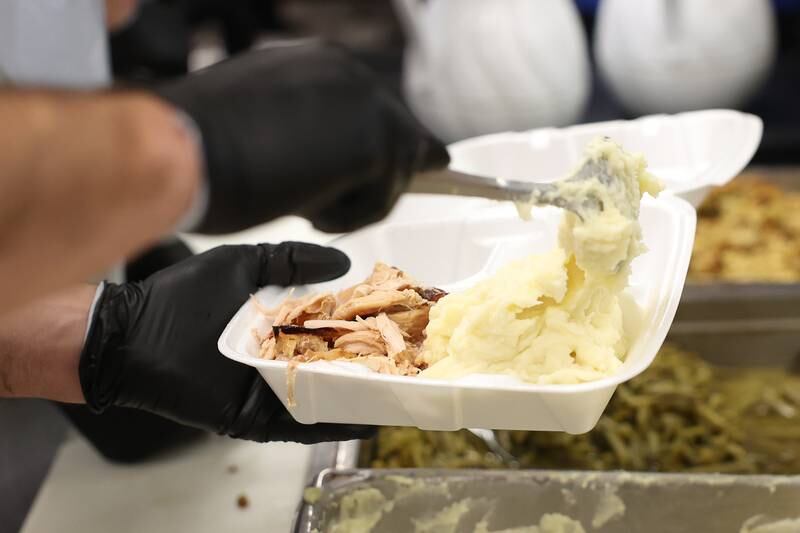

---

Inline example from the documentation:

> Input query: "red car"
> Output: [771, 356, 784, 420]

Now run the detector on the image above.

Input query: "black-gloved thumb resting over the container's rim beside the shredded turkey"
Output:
[257, 242, 350, 287]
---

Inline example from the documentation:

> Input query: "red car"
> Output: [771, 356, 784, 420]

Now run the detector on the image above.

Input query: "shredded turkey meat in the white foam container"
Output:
[254, 263, 445, 380]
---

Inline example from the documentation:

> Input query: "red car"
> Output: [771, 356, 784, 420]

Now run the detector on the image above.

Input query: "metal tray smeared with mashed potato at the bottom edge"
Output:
[294, 469, 800, 533]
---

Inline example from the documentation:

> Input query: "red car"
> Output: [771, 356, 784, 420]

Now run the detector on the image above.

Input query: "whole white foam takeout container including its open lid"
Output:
[219, 110, 763, 433]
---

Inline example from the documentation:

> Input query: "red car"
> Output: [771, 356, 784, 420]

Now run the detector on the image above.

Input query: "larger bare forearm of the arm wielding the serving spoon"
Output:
[0, 90, 201, 314]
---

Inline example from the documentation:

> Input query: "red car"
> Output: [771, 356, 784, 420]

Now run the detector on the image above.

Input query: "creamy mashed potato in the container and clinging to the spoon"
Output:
[421, 139, 660, 383]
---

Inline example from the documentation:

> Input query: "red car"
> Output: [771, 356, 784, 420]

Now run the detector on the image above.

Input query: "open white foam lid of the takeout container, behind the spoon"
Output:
[449, 109, 763, 207]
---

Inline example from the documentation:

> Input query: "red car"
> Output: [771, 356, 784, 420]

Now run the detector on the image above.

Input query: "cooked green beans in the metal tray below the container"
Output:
[364, 346, 800, 474]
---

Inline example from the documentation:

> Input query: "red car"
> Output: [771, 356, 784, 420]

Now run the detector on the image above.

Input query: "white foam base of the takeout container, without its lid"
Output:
[219, 191, 695, 433]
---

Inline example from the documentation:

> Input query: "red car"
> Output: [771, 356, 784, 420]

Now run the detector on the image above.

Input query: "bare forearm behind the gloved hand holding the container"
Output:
[0, 285, 96, 403]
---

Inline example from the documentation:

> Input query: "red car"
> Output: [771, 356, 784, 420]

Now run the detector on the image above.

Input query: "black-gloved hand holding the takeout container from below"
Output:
[79, 243, 371, 443]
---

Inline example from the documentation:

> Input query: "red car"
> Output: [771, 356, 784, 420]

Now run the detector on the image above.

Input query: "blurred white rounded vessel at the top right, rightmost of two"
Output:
[595, 0, 776, 114]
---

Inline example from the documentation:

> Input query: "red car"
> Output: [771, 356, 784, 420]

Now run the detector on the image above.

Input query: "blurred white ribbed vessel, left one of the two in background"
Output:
[395, 0, 591, 142]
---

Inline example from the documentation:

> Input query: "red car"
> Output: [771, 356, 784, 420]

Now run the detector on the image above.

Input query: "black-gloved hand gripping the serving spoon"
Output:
[156, 41, 449, 233]
